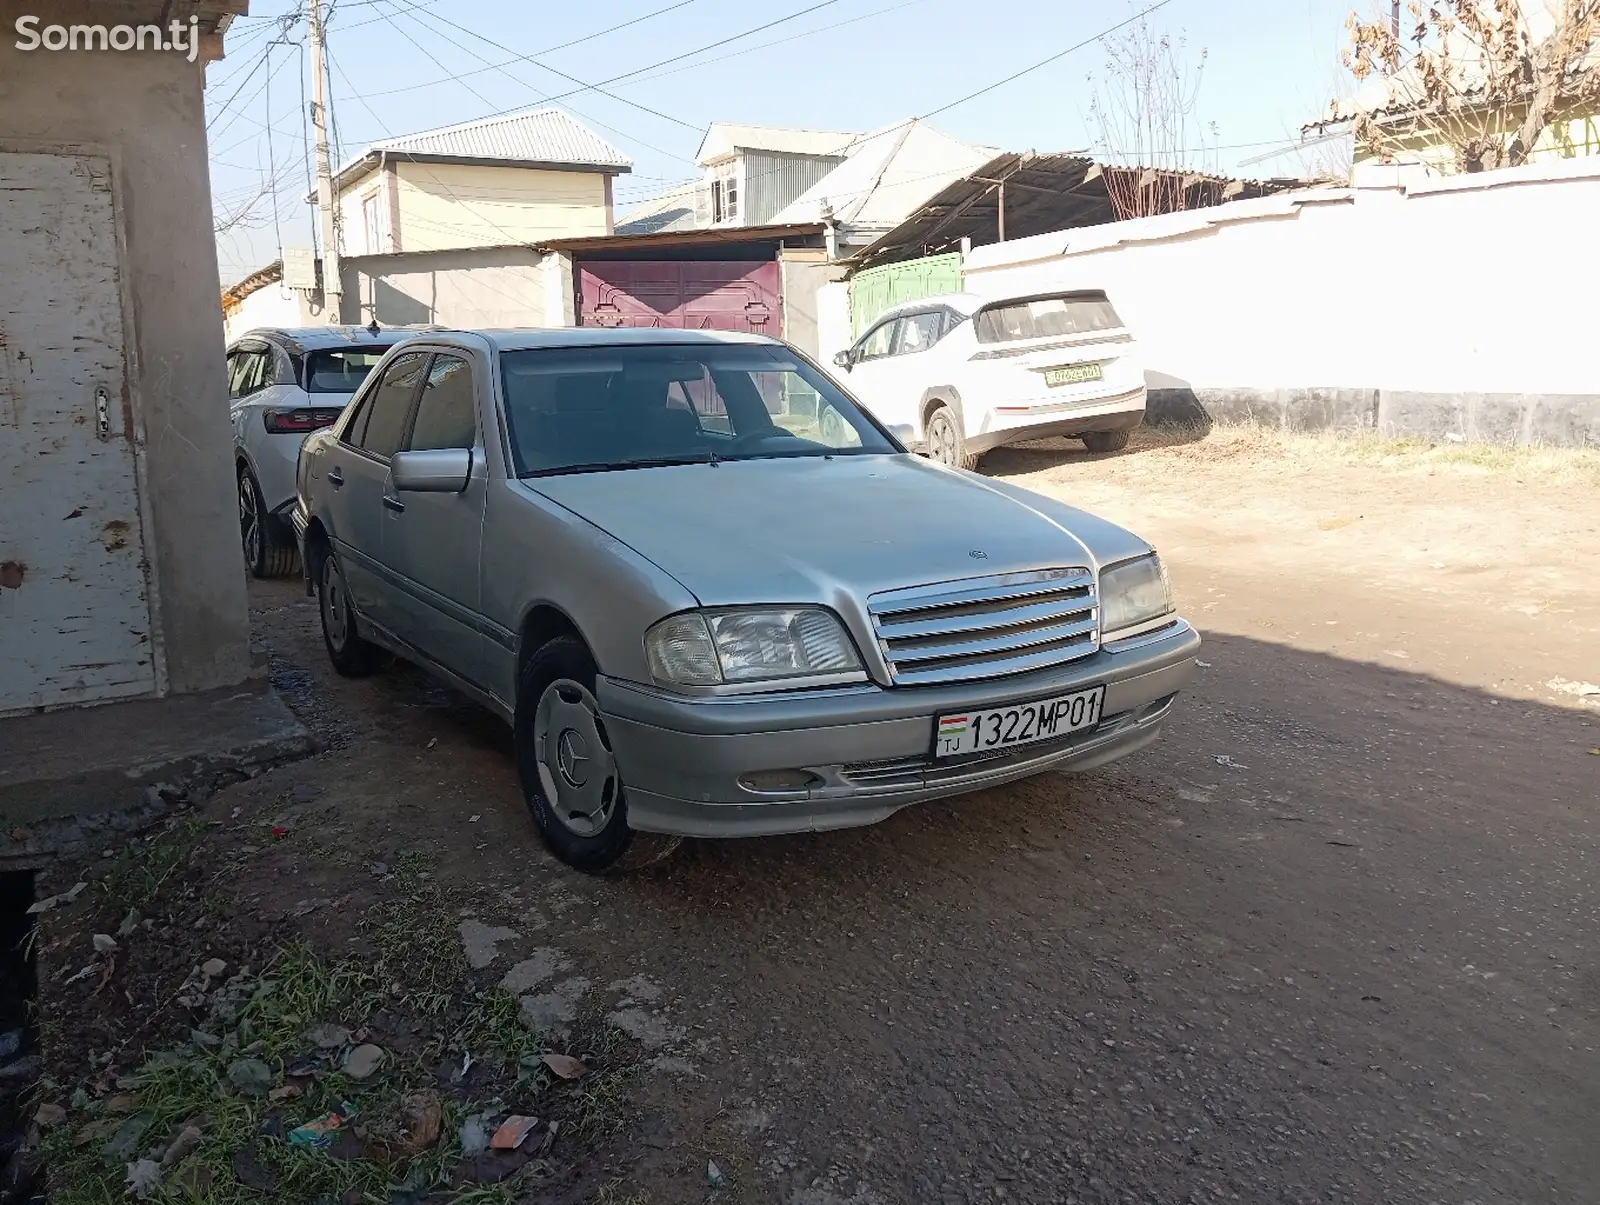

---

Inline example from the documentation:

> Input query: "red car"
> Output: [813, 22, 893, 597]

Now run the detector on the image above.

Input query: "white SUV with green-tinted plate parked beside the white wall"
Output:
[834, 291, 1144, 469]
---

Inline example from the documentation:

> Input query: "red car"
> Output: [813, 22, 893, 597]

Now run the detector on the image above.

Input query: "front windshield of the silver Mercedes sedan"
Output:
[501, 344, 901, 477]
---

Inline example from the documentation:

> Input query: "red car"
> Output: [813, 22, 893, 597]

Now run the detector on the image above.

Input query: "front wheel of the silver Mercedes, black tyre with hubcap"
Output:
[514, 635, 680, 872]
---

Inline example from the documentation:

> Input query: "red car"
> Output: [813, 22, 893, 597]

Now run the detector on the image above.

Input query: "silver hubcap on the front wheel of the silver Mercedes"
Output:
[533, 679, 621, 837]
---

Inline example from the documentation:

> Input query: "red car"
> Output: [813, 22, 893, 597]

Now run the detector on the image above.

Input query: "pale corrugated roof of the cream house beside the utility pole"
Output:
[339, 109, 634, 190]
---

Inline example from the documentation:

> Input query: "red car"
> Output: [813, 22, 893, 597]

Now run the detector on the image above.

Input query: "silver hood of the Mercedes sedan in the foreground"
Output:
[526, 454, 1149, 610]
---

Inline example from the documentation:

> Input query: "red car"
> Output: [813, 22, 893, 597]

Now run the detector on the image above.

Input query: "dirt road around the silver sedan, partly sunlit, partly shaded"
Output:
[28, 430, 1600, 1205]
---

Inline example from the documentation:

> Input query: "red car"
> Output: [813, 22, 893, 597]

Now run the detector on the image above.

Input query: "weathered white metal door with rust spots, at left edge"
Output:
[0, 152, 159, 715]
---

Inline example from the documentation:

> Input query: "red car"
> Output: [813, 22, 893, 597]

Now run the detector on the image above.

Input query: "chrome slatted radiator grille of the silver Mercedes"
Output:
[867, 568, 1099, 687]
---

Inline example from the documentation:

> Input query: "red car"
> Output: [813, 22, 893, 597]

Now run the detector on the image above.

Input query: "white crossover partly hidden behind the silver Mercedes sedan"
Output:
[227, 326, 418, 578]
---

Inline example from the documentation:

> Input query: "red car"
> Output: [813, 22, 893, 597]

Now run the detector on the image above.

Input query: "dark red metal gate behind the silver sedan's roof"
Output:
[578, 259, 782, 339]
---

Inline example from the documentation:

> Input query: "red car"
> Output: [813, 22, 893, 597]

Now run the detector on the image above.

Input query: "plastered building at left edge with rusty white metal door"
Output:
[0, 0, 251, 713]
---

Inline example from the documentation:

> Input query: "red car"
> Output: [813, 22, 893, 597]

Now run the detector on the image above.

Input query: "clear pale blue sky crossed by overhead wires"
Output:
[208, 0, 1373, 282]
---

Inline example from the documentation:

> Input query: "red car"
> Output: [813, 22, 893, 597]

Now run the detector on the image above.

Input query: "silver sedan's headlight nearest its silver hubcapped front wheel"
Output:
[645, 607, 866, 687]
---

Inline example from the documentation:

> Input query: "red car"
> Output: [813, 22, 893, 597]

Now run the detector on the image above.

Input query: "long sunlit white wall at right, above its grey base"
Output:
[965, 160, 1600, 442]
